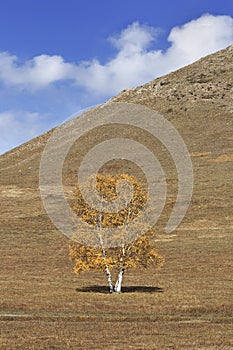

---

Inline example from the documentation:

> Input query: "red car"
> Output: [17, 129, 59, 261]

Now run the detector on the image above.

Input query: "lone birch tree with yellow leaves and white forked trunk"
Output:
[70, 174, 163, 293]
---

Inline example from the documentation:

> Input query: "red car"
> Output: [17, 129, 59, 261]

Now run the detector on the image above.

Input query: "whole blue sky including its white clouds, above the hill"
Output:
[0, 0, 233, 153]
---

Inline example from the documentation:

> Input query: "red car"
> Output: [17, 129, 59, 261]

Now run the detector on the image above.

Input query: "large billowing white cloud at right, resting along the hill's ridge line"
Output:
[77, 14, 233, 94]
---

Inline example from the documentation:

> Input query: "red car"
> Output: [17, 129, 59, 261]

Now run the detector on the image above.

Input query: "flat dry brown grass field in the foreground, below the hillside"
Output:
[0, 230, 233, 349]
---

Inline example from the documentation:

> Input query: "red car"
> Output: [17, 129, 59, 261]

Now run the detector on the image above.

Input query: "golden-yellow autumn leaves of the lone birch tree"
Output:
[70, 174, 163, 273]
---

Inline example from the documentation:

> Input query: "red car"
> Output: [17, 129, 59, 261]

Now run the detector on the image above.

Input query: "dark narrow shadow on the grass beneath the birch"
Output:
[76, 286, 163, 294]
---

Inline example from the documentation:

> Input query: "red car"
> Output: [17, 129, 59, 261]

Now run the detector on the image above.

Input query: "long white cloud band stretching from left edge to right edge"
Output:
[0, 14, 233, 96]
